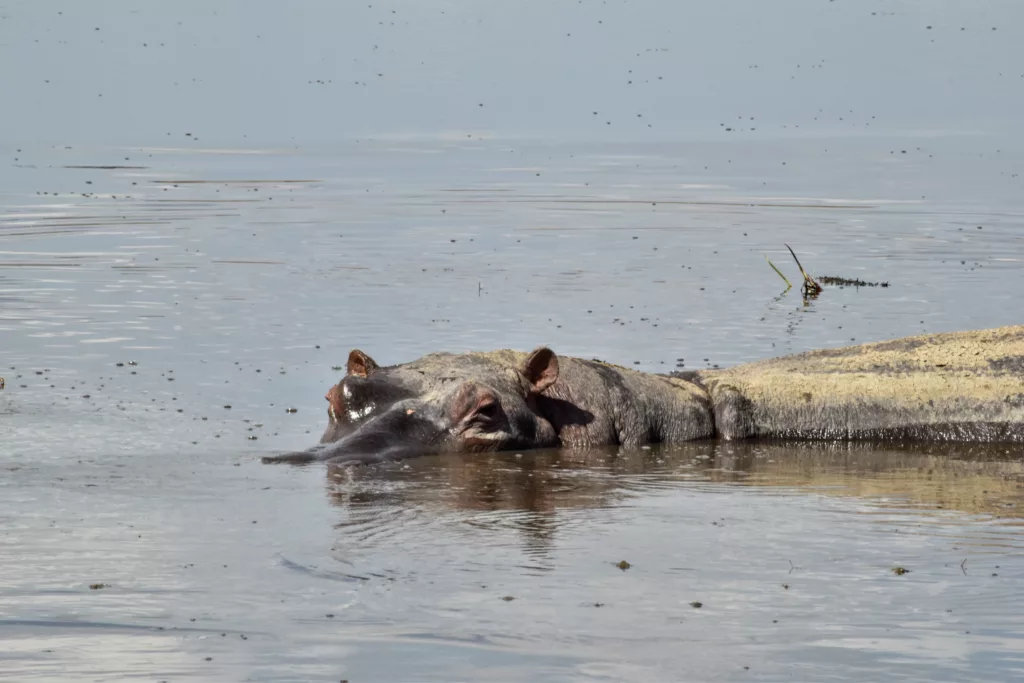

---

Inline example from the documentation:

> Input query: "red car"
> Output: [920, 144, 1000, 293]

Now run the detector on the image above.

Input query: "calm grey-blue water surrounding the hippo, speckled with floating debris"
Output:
[0, 0, 1024, 683]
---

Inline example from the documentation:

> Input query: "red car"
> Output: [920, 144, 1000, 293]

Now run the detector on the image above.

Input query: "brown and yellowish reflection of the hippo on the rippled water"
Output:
[328, 442, 1024, 565]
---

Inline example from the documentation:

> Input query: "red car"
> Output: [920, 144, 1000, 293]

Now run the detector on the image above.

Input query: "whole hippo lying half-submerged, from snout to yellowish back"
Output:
[264, 326, 1024, 463]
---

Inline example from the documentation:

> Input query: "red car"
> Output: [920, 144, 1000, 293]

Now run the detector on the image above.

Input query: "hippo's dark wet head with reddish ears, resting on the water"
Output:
[265, 347, 558, 463]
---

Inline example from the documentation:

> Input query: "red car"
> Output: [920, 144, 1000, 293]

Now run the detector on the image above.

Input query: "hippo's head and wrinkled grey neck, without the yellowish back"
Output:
[264, 347, 713, 463]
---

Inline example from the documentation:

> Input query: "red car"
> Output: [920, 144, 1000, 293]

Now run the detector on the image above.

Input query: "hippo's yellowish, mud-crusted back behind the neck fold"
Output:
[697, 326, 1024, 442]
